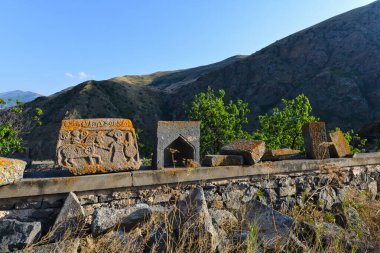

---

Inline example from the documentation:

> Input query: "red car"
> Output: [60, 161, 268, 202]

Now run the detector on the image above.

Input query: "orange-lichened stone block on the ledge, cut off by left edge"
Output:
[0, 157, 26, 186]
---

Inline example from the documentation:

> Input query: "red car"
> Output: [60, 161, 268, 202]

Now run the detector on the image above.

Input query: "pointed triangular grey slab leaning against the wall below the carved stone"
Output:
[50, 192, 86, 241]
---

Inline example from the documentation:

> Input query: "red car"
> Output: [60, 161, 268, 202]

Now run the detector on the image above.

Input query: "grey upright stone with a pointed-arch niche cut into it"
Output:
[153, 121, 201, 169]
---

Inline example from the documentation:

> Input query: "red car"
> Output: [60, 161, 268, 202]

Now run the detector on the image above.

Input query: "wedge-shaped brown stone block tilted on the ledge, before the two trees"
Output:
[220, 140, 265, 165]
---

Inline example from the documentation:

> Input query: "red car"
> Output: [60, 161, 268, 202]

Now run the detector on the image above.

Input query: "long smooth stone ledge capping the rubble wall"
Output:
[0, 155, 380, 199]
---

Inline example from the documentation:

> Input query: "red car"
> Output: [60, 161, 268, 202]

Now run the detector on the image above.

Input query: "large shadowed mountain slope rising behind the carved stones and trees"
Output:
[0, 1, 380, 159]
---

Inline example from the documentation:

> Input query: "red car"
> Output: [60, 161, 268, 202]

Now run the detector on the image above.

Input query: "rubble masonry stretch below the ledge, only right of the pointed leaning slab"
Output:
[78, 165, 380, 215]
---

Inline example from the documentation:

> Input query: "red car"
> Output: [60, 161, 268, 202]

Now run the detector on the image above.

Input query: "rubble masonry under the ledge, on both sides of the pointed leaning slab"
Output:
[0, 160, 380, 230]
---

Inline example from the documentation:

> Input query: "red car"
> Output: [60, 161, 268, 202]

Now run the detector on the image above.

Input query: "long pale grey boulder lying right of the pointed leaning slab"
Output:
[91, 204, 152, 236]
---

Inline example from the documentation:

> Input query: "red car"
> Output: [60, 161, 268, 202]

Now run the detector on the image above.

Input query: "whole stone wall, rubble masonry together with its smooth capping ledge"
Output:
[0, 158, 380, 231]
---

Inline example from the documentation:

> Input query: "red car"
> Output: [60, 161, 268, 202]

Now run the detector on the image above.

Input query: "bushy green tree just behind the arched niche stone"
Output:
[186, 87, 251, 156]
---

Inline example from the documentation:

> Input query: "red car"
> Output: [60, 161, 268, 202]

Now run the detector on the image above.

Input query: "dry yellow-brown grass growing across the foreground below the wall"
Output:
[26, 187, 380, 253]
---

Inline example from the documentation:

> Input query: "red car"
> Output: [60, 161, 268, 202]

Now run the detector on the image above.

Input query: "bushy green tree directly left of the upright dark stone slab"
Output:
[253, 94, 319, 150]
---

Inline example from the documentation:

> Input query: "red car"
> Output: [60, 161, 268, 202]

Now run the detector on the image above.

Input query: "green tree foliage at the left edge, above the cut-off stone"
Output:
[0, 98, 43, 156]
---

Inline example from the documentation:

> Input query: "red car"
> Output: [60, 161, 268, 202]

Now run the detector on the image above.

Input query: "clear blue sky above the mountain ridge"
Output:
[0, 0, 373, 95]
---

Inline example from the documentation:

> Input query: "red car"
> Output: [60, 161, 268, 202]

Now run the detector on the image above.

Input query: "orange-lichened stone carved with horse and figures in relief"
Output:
[56, 119, 141, 175]
